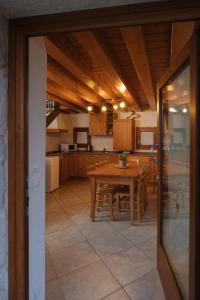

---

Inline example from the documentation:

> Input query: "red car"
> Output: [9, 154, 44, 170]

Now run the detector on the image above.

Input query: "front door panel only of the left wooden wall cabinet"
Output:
[89, 113, 108, 135]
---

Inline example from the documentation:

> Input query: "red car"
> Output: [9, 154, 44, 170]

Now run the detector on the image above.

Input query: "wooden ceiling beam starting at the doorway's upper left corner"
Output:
[44, 34, 115, 99]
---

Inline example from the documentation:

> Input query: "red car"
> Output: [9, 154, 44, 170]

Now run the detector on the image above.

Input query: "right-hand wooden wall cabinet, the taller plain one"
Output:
[113, 119, 135, 151]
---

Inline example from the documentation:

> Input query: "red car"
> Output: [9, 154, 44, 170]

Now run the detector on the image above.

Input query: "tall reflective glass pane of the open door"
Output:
[161, 66, 190, 299]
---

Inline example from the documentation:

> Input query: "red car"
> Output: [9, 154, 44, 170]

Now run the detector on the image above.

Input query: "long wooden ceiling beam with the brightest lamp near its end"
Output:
[73, 31, 141, 110]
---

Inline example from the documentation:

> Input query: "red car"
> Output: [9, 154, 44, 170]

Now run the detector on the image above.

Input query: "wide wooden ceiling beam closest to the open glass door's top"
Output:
[120, 26, 156, 110]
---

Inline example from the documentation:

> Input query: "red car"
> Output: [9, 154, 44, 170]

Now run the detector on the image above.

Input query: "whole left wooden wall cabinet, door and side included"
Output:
[89, 112, 117, 135]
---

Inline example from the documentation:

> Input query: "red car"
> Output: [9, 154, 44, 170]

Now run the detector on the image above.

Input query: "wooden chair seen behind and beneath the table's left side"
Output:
[88, 160, 116, 221]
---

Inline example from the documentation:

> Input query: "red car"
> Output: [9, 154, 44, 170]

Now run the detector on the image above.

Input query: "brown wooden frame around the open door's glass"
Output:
[157, 30, 200, 300]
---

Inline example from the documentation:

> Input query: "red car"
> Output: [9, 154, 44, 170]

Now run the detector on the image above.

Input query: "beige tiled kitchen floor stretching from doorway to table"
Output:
[46, 179, 165, 300]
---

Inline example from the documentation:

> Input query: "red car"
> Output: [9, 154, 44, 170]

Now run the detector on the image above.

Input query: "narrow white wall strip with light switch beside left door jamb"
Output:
[28, 38, 47, 300]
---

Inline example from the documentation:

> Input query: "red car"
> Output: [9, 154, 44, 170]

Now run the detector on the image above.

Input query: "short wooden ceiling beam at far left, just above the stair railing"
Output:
[47, 79, 89, 109]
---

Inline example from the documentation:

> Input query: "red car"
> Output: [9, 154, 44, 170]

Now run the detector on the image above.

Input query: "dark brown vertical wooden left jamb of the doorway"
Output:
[8, 24, 29, 299]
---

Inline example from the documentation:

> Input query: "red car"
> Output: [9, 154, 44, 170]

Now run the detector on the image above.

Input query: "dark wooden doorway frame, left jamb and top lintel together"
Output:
[8, 0, 200, 300]
